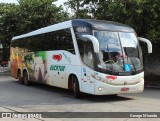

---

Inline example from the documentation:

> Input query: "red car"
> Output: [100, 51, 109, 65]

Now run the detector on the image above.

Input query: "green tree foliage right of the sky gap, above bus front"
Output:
[67, 0, 160, 42]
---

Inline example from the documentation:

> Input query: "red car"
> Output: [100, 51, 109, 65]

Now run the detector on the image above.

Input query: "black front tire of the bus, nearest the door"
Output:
[72, 77, 81, 99]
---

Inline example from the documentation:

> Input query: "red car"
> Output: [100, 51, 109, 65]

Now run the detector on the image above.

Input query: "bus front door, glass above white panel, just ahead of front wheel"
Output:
[80, 42, 95, 94]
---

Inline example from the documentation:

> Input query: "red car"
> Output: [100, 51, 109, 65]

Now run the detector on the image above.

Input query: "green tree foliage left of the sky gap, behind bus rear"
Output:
[0, 0, 69, 59]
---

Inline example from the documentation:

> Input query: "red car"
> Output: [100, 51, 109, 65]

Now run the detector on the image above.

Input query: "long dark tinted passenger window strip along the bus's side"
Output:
[12, 29, 75, 54]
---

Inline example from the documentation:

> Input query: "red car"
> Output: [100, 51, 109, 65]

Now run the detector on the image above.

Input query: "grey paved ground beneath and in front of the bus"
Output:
[0, 72, 160, 121]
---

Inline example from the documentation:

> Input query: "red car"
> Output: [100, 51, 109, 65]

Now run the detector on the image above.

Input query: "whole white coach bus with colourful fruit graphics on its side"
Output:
[10, 19, 152, 98]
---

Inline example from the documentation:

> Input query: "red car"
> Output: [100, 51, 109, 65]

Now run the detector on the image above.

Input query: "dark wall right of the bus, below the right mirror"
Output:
[144, 43, 160, 87]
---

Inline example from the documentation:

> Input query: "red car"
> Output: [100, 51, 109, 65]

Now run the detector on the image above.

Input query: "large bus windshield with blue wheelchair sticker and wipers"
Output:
[94, 31, 143, 73]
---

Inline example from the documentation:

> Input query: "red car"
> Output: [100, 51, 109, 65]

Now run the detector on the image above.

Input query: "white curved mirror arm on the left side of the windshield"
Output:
[82, 35, 99, 53]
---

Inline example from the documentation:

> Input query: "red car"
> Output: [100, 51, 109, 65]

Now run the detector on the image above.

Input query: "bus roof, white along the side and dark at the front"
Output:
[12, 19, 134, 40]
